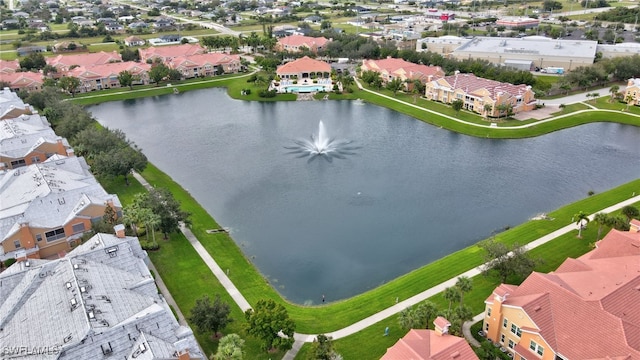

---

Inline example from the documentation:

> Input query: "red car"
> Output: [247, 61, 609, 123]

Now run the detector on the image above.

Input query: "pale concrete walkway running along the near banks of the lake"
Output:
[133, 172, 640, 360]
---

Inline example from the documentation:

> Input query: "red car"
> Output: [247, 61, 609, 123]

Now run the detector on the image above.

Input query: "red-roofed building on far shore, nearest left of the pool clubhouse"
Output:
[167, 53, 242, 79]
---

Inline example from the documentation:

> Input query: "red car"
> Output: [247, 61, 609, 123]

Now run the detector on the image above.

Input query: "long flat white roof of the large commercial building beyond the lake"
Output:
[455, 36, 598, 59]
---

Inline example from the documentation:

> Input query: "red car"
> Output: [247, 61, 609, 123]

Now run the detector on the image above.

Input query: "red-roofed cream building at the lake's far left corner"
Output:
[66, 61, 151, 92]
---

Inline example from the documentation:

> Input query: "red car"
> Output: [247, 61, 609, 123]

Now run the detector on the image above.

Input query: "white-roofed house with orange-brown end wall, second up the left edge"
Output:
[0, 114, 74, 170]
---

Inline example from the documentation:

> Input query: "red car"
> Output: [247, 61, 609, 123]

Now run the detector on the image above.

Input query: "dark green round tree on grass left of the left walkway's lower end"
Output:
[189, 294, 233, 336]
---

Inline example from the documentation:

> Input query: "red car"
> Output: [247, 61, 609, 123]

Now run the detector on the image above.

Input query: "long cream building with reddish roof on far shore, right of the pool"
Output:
[425, 72, 536, 117]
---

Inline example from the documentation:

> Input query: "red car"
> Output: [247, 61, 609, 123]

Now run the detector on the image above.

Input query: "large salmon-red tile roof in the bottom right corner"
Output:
[487, 230, 640, 359]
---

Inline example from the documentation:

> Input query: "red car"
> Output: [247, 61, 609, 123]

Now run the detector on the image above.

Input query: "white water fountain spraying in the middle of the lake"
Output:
[285, 120, 359, 162]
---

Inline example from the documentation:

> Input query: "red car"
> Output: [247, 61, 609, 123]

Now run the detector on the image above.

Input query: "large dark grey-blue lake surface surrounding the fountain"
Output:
[89, 89, 640, 303]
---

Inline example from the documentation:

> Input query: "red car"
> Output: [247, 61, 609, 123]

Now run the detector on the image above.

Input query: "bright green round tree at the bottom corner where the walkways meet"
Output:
[244, 299, 295, 350]
